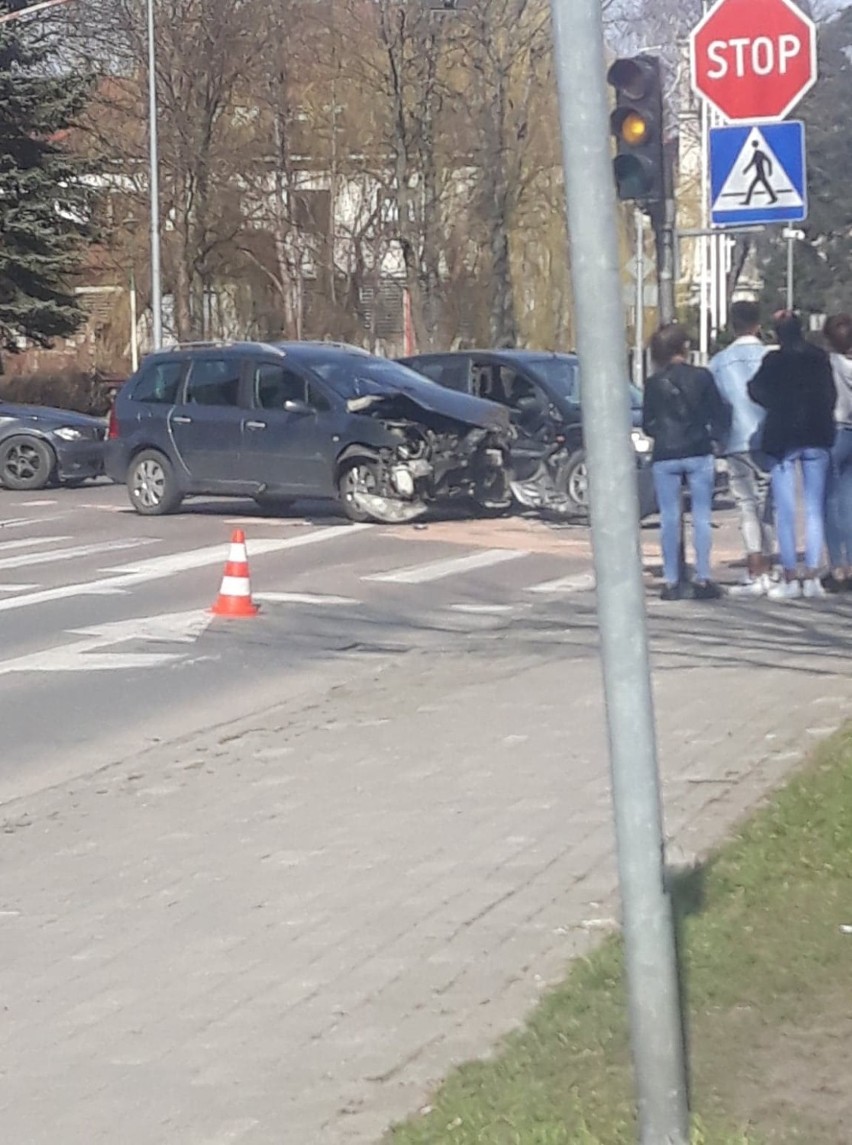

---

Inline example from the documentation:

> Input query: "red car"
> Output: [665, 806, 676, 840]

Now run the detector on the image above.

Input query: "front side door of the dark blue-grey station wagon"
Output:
[242, 361, 340, 497]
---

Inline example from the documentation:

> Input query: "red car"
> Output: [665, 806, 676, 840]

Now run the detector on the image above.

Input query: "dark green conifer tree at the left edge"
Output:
[0, 0, 92, 350]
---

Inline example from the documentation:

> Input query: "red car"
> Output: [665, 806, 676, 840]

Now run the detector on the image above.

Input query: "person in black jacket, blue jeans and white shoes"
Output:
[749, 310, 837, 600]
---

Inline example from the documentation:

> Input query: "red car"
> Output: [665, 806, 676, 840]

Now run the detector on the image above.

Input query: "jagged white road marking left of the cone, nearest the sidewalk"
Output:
[0, 609, 213, 676]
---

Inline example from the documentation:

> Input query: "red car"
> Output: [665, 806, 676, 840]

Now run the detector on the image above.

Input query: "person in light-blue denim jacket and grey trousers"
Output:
[710, 301, 775, 597]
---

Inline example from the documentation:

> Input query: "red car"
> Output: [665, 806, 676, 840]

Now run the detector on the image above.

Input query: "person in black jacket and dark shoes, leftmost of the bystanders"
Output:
[642, 324, 731, 600]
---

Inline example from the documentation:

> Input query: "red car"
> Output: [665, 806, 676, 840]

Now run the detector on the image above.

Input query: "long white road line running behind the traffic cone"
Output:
[0, 524, 372, 613]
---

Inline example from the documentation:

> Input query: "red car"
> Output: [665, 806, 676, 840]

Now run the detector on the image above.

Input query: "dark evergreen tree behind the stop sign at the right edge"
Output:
[760, 8, 852, 314]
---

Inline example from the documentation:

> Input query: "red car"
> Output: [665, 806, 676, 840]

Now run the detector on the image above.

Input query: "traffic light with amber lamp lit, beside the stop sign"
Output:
[607, 55, 666, 203]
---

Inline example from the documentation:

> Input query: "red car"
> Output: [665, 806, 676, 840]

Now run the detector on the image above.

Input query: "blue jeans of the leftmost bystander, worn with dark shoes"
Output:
[654, 453, 716, 584]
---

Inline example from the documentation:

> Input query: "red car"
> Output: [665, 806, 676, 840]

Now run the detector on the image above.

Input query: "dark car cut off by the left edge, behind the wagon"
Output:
[0, 401, 107, 489]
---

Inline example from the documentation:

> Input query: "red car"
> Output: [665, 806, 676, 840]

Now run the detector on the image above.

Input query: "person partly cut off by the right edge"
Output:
[822, 314, 852, 592]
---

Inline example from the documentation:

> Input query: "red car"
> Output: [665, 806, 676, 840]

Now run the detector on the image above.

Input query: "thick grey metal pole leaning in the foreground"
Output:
[551, 0, 689, 1145]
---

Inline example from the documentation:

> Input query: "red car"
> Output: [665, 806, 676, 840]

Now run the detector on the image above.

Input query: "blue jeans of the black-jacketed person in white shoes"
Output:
[772, 449, 830, 573]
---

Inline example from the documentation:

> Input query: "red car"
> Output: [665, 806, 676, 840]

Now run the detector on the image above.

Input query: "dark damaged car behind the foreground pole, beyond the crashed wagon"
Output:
[399, 350, 656, 516]
